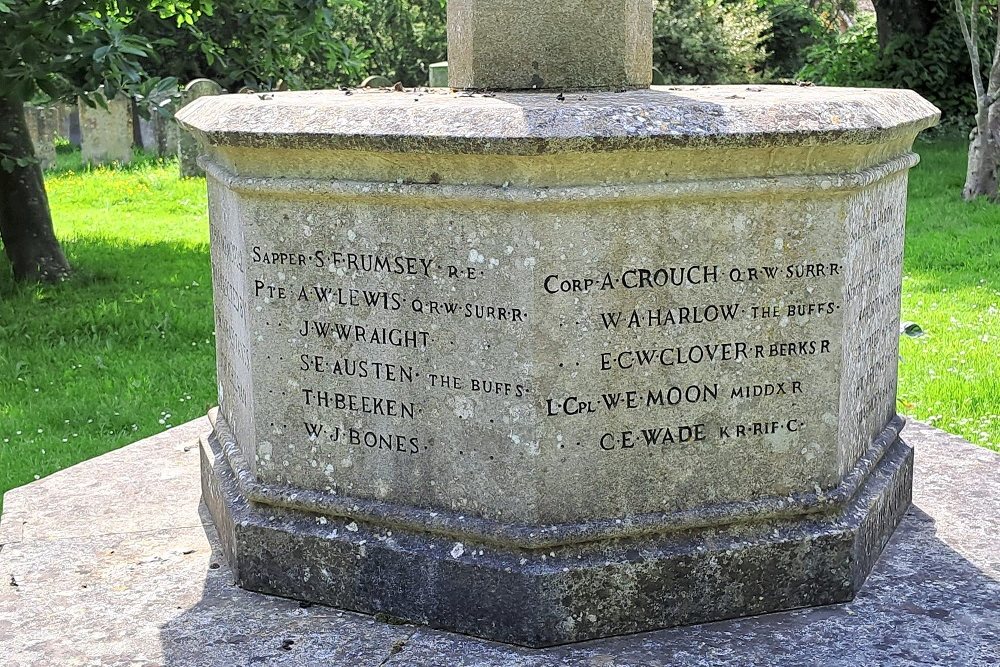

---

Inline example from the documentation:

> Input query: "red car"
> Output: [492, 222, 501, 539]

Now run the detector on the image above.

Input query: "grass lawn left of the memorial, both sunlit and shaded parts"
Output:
[0, 153, 215, 506]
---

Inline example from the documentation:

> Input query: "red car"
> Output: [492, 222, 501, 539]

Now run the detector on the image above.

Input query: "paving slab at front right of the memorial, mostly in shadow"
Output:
[388, 423, 1000, 667]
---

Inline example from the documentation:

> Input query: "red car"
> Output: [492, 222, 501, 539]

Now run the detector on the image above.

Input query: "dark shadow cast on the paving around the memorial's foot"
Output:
[160, 503, 1000, 667]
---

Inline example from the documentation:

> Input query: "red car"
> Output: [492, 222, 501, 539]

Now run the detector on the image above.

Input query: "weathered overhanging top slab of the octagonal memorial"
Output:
[177, 86, 940, 155]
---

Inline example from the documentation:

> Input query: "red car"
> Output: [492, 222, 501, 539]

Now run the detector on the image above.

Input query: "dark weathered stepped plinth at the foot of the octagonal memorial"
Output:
[201, 412, 913, 647]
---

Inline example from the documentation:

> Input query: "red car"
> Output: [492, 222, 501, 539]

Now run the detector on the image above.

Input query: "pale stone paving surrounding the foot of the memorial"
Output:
[0, 420, 1000, 667]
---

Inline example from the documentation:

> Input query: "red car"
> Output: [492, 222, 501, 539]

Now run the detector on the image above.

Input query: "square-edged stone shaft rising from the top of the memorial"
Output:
[448, 0, 653, 90]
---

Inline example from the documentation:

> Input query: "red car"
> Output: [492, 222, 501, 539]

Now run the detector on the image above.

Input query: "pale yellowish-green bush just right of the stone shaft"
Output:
[653, 0, 769, 84]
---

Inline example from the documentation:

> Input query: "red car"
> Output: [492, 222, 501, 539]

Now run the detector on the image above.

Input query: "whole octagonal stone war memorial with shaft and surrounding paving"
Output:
[0, 0, 1000, 667]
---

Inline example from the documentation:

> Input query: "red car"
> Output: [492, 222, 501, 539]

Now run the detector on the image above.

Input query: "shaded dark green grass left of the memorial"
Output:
[0, 239, 216, 504]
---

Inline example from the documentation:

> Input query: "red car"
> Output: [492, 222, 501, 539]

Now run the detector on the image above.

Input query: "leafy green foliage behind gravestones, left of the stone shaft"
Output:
[131, 0, 447, 90]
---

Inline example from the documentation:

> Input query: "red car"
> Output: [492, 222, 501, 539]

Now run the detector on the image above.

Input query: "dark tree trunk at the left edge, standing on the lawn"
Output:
[0, 97, 69, 282]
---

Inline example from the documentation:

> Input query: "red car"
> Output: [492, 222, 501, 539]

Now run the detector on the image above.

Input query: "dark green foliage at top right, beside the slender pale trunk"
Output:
[799, 5, 995, 124]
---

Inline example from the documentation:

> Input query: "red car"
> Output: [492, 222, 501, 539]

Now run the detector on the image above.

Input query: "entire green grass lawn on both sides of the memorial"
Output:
[0, 142, 1000, 506]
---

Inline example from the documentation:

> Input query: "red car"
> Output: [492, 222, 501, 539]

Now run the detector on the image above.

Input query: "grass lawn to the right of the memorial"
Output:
[899, 141, 1000, 451]
